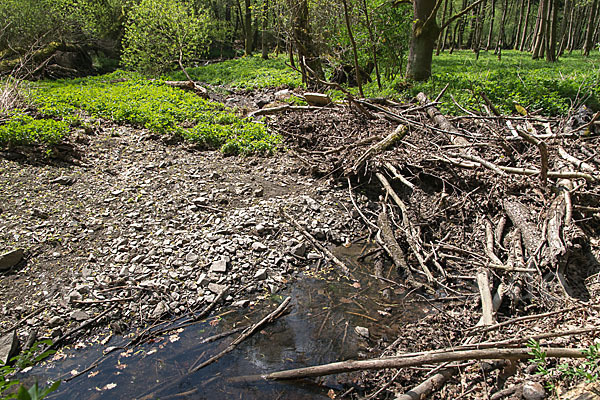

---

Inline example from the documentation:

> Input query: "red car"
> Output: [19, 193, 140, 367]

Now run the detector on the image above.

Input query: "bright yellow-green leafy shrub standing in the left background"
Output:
[122, 0, 211, 74]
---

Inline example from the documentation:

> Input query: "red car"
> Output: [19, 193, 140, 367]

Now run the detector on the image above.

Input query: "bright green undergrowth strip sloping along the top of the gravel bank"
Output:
[25, 71, 280, 154]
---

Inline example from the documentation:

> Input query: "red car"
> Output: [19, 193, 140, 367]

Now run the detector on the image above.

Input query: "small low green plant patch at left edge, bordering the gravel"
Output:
[0, 111, 69, 146]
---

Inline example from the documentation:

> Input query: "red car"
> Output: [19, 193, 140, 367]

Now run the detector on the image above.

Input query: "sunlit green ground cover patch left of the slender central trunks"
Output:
[169, 56, 302, 89]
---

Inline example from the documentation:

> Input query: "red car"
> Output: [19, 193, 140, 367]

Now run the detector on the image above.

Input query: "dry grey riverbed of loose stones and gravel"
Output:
[0, 126, 366, 354]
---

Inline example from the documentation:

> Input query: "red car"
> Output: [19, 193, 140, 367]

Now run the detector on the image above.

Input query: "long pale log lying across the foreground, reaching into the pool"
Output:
[258, 347, 585, 380]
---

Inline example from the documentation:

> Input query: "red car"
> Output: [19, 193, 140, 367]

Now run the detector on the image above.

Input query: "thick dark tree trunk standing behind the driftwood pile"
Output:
[406, 0, 440, 81]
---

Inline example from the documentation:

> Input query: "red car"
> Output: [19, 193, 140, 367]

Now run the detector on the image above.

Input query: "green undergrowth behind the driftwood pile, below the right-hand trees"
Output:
[356, 51, 600, 115]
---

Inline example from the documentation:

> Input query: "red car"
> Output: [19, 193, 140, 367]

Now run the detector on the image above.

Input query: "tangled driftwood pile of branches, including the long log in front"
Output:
[255, 93, 600, 399]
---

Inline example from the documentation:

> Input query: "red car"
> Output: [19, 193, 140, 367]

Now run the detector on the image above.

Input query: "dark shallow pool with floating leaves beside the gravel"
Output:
[30, 245, 427, 399]
